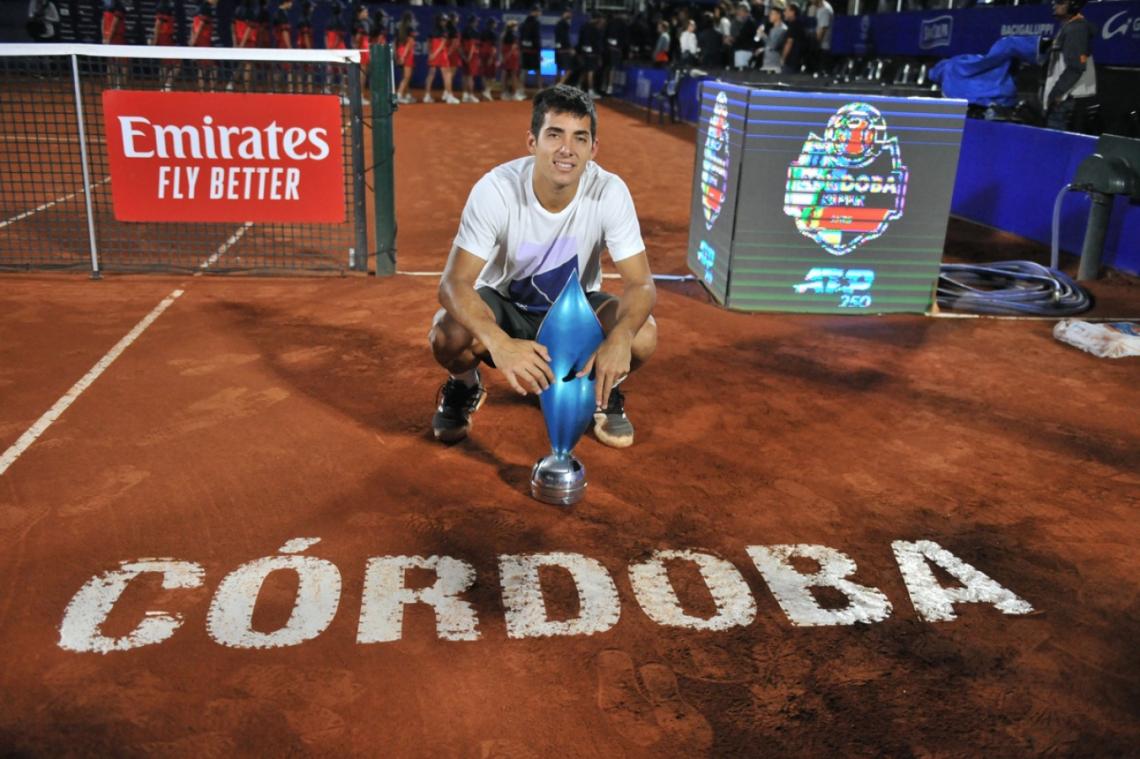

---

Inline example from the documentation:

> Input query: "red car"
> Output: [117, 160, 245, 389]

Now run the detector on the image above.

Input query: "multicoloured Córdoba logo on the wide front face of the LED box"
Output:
[784, 103, 907, 255]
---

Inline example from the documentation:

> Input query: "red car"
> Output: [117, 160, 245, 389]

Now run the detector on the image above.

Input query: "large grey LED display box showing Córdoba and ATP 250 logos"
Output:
[689, 81, 966, 313]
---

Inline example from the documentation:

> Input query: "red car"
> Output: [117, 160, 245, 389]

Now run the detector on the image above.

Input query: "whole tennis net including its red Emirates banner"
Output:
[0, 44, 368, 276]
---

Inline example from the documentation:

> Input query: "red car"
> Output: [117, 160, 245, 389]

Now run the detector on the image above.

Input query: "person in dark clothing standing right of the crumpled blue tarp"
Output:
[1042, 0, 1097, 130]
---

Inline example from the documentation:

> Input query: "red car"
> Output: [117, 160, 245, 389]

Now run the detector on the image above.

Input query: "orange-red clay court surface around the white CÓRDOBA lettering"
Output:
[0, 103, 1140, 757]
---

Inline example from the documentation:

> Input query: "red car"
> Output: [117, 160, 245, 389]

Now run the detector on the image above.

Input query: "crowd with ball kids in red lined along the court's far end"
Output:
[20, 0, 834, 104]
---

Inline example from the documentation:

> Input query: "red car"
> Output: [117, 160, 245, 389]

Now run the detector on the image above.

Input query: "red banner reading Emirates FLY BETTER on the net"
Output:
[103, 90, 344, 223]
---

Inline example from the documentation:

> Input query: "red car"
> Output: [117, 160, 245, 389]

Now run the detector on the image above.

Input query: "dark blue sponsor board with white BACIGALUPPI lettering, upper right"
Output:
[831, 0, 1140, 66]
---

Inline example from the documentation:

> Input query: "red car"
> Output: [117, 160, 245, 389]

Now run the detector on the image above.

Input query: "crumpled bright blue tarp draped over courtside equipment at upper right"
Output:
[930, 36, 1041, 107]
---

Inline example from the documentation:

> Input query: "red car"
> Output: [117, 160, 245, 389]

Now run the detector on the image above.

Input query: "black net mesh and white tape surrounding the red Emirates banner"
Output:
[0, 44, 368, 276]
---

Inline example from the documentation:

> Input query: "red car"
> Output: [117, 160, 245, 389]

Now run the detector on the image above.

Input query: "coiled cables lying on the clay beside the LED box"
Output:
[938, 261, 1092, 317]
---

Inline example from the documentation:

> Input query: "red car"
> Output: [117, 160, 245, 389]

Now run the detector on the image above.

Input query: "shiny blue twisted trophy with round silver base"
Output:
[530, 276, 605, 506]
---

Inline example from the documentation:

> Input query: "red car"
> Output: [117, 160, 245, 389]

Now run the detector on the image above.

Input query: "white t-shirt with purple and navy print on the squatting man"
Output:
[455, 156, 645, 313]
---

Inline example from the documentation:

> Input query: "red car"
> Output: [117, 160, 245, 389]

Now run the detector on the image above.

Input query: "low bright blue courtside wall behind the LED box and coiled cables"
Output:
[621, 67, 1140, 275]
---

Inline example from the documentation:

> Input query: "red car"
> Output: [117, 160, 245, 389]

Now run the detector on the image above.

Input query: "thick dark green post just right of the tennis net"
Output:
[371, 44, 396, 277]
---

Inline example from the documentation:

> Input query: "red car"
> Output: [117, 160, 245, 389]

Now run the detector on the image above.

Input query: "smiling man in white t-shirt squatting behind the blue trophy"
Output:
[430, 84, 657, 448]
